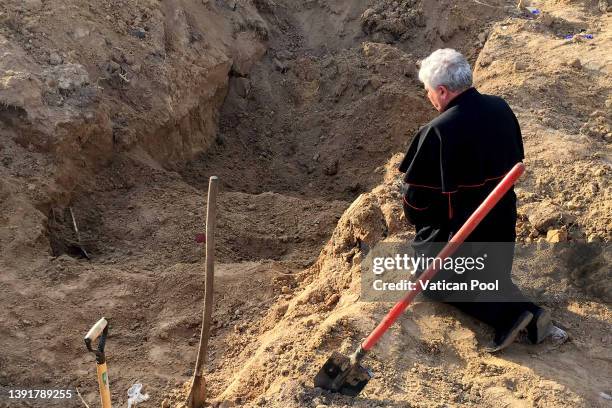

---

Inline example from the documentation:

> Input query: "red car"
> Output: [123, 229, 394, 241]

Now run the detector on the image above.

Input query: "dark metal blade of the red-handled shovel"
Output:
[314, 351, 372, 397]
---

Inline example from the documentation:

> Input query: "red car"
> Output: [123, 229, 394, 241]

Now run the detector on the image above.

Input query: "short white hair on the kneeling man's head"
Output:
[419, 48, 472, 92]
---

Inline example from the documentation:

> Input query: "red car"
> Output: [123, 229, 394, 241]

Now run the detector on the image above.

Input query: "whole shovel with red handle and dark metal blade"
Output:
[314, 163, 525, 396]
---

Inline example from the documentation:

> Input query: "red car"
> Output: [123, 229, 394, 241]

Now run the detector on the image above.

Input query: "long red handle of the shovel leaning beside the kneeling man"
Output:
[361, 163, 525, 351]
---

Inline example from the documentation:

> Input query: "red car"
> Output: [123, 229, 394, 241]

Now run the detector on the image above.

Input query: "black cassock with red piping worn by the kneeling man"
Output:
[399, 88, 539, 331]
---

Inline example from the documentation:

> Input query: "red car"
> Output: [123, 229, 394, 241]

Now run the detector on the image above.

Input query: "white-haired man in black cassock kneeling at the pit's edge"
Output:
[399, 49, 566, 351]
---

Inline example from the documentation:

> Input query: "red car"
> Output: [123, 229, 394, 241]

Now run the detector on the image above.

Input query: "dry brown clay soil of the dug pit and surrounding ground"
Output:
[0, 0, 612, 408]
